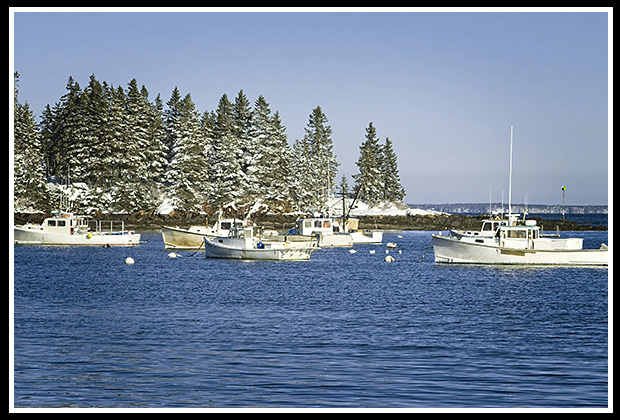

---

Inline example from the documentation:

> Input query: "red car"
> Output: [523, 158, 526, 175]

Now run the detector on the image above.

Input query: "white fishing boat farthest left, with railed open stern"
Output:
[13, 211, 140, 246]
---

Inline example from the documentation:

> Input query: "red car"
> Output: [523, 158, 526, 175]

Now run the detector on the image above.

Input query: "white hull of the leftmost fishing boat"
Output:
[13, 227, 140, 246]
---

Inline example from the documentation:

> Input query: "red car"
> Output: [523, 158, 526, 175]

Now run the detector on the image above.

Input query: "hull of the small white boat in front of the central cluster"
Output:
[204, 238, 319, 261]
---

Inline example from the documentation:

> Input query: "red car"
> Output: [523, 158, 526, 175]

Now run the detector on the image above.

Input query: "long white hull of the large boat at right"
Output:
[433, 235, 609, 266]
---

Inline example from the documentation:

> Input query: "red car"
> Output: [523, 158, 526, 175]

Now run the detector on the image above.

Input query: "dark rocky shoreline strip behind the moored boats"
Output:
[14, 211, 607, 232]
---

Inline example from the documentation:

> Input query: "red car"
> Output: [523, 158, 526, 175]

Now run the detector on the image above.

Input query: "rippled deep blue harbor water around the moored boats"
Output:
[14, 228, 608, 408]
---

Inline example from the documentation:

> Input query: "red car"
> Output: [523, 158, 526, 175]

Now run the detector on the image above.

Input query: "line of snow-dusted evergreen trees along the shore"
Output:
[13, 73, 405, 213]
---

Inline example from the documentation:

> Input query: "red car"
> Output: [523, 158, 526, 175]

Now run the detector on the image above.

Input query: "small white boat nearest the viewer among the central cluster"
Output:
[204, 226, 320, 260]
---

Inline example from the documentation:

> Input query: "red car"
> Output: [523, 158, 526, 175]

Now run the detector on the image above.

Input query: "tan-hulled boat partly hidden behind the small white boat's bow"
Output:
[161, 217, 247, 249]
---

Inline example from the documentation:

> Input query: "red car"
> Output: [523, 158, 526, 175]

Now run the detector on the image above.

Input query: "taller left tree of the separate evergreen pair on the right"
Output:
[354, 122, 384, 206]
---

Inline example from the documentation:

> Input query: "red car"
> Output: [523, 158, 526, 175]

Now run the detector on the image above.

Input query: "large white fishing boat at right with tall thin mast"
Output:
[432, 125, 609, 266]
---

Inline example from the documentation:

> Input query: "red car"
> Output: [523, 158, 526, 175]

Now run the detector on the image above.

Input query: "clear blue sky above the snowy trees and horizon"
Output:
[11, 9, 611, 204]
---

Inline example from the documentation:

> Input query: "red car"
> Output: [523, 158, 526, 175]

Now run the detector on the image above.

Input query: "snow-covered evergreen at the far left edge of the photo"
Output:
[13, 73, 50, 209]
